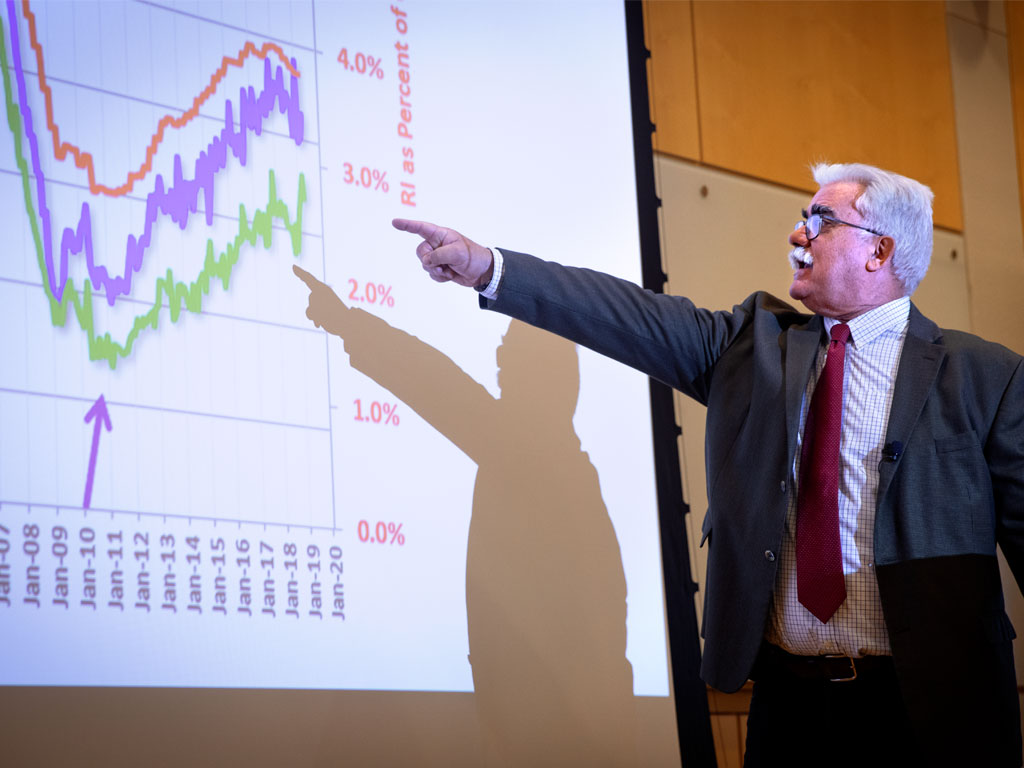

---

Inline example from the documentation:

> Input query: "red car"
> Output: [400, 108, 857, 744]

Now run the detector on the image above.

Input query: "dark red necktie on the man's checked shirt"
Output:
[797, 323, 850, 624]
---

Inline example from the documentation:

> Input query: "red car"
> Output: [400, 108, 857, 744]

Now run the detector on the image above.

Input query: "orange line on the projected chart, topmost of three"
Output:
[22, 0, 299, 198]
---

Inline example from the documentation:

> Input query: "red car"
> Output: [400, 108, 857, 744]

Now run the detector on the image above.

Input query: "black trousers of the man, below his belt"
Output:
[743, 646, 924, 768]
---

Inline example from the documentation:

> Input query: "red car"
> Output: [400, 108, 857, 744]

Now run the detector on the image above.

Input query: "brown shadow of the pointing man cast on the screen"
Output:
[296, 268, 635, 766]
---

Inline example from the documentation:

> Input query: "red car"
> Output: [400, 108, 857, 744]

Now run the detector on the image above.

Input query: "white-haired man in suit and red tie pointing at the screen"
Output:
[310, 165, 1024, 766]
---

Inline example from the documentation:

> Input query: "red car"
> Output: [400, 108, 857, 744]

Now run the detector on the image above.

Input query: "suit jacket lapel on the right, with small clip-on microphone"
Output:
[878, 303, 946, 509]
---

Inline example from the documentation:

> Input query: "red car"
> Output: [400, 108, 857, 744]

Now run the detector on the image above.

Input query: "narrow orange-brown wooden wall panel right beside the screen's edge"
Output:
[643, 0, 700, 160]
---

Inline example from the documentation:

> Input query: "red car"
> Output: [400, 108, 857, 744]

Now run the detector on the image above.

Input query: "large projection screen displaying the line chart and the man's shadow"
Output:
[0, 0, 696, 765]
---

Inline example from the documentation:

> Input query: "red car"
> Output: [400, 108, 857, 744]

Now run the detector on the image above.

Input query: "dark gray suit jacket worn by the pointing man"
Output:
[481, 249, 1024, 765]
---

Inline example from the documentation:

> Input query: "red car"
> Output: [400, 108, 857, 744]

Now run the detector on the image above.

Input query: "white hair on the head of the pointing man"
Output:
[811, 163, 935, 296]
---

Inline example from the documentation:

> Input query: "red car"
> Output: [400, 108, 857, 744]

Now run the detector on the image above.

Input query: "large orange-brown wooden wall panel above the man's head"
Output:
[688, 1, 963, 230]
